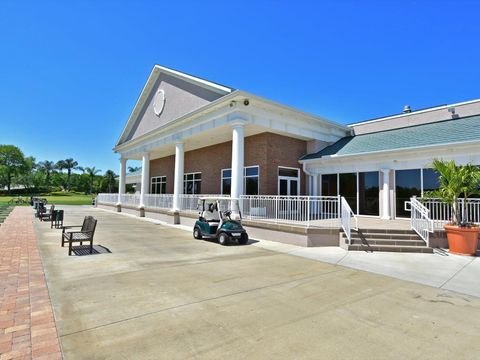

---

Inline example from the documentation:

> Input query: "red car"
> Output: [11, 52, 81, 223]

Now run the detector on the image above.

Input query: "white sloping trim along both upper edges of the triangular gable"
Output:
[116, 65, 235, 146]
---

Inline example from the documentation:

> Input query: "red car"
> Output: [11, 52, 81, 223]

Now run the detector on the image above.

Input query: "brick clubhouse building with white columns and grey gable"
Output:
[96, 65, 480, 248]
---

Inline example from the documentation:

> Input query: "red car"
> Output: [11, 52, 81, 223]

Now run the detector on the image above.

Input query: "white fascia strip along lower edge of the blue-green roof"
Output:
[299, 140, 480, 164]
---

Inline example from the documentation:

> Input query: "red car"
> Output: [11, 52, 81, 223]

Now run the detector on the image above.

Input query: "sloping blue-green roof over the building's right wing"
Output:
[300, 115, 480, 160]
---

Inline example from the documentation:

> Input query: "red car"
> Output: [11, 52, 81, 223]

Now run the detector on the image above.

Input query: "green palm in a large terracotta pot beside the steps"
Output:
[427, 159, 480, 255]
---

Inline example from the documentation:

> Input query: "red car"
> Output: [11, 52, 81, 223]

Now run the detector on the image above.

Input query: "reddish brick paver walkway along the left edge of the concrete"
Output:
[0, 207, 62, 360]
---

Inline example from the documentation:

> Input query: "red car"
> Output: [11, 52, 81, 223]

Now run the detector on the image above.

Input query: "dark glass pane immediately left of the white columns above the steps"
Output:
[358, 171, 380, 216]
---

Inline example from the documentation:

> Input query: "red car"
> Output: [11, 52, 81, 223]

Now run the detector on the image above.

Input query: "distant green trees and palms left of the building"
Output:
[0, 145, 124, 194]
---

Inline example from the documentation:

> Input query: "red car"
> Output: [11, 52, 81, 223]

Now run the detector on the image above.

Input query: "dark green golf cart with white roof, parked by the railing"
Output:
[193, 197, 248, 245]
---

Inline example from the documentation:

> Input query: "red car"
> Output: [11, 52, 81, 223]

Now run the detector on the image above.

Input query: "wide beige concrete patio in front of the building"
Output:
[35, 206, 480, 359]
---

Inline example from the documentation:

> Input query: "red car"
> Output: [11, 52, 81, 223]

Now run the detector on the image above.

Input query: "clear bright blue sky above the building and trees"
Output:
[0, 0, 480, 171]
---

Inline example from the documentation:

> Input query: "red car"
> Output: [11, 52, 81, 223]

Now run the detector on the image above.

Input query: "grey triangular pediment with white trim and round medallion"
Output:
[117, 65, 233, 146]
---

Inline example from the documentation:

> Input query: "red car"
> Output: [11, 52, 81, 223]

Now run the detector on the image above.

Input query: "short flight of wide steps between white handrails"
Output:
[341, 229, 433, 253]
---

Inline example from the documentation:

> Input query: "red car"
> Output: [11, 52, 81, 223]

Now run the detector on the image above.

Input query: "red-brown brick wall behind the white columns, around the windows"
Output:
[150, 133, 307, 195]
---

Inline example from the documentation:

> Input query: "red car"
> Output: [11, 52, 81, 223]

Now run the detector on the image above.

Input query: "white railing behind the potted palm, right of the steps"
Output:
[421, 198, 480, 230]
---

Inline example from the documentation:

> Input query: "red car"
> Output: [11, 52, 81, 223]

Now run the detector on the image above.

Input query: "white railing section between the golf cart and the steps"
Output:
[239, 195, 340, 227]
